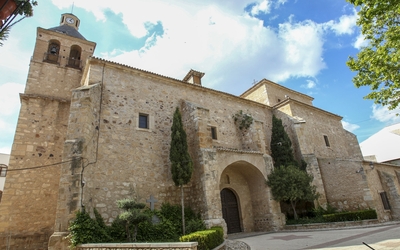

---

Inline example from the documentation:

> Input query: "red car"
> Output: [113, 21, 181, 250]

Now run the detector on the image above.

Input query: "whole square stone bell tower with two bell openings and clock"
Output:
[0, 13, 96, 249]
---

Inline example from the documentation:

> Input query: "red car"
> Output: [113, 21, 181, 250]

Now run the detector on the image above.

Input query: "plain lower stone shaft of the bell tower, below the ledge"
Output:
[0, 95, 69, 249]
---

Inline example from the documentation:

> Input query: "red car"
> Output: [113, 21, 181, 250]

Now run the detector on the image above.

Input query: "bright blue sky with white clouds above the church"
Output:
[0, 0, 400, 153]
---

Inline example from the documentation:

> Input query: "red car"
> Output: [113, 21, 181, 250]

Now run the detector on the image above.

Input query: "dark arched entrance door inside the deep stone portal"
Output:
[221, 188, 242, 234]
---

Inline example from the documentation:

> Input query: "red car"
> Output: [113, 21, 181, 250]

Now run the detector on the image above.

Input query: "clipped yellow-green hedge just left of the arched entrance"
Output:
[179, 227, 224, 250]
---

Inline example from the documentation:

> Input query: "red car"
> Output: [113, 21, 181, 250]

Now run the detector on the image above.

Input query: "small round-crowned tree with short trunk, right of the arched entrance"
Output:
[267, 165, 318, 219]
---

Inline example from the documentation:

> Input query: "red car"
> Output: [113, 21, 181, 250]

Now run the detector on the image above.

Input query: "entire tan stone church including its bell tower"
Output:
[0, 13, 400, 249]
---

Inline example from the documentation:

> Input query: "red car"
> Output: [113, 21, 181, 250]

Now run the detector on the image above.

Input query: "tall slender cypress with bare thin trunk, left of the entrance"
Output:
[169, 108, 193, 234]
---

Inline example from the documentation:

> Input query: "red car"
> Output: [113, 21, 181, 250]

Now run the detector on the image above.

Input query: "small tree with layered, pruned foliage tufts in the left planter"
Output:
[117, 199, 148, 242]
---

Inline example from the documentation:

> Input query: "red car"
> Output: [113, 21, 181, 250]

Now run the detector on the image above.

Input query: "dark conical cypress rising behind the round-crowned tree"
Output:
[271, 115, 298, 168]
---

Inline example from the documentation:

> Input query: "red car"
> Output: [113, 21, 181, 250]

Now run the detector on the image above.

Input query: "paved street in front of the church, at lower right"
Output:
[228, 224, 400, 250]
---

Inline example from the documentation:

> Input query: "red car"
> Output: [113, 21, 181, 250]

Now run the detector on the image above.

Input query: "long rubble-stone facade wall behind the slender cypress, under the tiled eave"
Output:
[71, 59, 282, 223]
